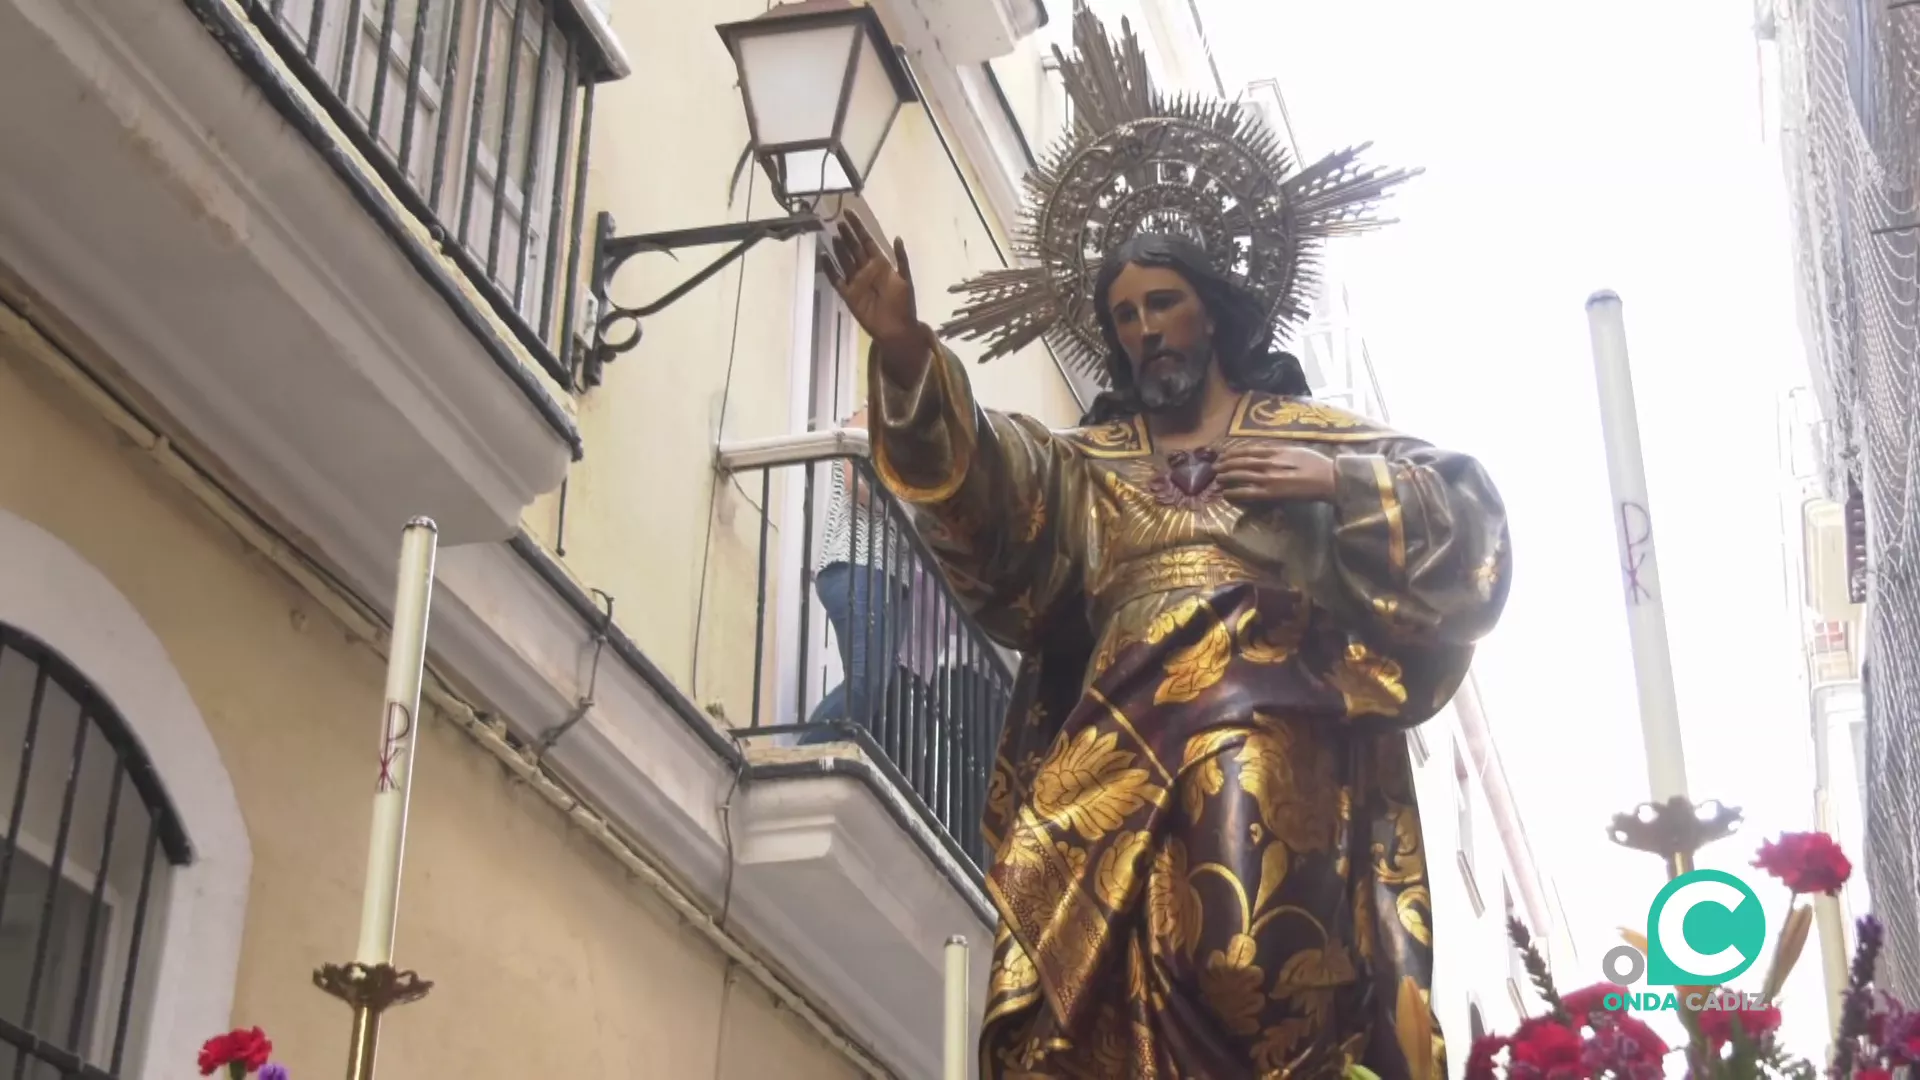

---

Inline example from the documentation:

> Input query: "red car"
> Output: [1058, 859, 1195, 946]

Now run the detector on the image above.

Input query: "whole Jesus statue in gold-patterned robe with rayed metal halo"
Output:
[822, 10, 1511, 1080]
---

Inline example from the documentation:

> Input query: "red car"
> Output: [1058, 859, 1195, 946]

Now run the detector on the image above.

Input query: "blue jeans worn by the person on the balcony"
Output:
[801, 561, 908, 744]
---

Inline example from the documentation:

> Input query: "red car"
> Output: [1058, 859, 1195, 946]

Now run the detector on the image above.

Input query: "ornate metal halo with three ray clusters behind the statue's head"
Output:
[941, 6, 1419, 384]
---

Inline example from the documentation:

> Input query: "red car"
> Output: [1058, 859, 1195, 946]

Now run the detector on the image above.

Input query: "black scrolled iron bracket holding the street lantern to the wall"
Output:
[582, 211, 826, 386]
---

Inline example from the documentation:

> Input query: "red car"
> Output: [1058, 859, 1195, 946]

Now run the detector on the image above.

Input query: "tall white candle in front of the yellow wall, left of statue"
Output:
[353, 517, 440, 967]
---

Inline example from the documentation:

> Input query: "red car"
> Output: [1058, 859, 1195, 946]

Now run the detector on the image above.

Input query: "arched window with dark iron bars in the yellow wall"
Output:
[0, 623, 192, 1080]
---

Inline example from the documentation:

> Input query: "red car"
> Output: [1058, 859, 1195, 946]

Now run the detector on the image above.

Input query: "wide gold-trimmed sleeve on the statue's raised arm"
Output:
[868, 329, 1092, 651]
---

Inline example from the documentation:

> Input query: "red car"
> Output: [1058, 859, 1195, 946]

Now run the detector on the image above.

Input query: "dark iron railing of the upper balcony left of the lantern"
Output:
[227, 0, 601, 388]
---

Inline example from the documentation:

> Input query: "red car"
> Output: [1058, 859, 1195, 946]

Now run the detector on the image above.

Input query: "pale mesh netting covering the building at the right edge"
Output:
[1763, 0, 1920, 1001]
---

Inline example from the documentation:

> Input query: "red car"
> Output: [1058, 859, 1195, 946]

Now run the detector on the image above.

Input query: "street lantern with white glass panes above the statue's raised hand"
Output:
[718, 0, 914, 204]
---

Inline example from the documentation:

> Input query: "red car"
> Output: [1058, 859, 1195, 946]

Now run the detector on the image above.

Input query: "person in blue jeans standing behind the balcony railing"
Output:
[799, 405, 912, 746]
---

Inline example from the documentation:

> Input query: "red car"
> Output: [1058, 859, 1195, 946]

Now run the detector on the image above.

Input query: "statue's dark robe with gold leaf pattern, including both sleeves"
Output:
[870, 330, 1509, 1080]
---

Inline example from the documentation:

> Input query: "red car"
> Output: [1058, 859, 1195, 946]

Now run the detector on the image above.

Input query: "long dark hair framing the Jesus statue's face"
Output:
[1081, 233, 1311, 425]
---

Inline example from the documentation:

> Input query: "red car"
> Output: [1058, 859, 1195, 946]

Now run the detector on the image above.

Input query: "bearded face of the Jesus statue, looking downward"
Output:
[1106, 263, 1213, 411]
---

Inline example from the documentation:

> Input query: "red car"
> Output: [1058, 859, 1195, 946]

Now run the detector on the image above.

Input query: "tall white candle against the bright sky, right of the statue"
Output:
[1586, 292, 1686, 803]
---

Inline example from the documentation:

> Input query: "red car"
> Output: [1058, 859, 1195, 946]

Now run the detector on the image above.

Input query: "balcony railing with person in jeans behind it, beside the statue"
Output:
[720, 430, 1014, 871]
